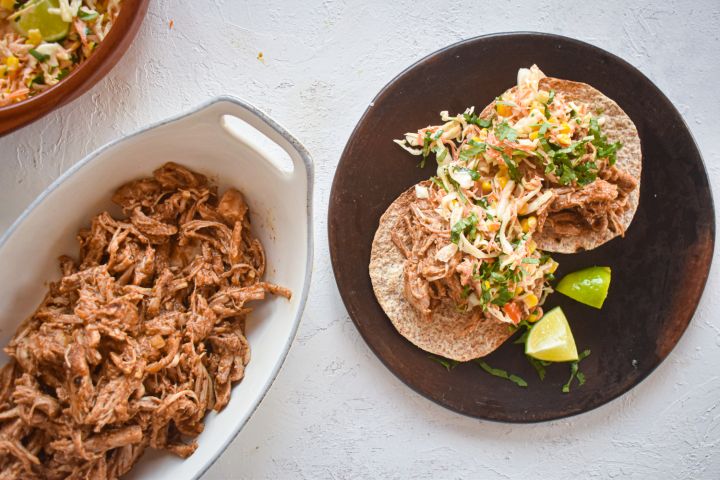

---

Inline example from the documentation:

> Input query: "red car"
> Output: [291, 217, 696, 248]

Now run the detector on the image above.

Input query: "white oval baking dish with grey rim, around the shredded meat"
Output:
[0, 97, 313, 480]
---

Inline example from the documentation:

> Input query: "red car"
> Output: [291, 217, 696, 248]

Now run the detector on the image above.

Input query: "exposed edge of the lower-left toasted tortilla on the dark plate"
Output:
[370, 182, 513, 362]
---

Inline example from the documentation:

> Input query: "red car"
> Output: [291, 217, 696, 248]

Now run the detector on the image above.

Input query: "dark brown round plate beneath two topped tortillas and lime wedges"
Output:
[328, 33, 715, 422]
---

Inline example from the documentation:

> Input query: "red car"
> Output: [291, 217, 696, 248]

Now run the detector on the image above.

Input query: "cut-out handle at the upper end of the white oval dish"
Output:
[201, 96, 313, 184]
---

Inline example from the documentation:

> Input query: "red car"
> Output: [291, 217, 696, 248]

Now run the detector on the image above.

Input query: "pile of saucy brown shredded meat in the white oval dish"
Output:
[0, 163, 291, 479]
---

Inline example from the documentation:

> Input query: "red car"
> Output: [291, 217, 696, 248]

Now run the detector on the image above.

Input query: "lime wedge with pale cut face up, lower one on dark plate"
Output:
[525, 307, 578, 362]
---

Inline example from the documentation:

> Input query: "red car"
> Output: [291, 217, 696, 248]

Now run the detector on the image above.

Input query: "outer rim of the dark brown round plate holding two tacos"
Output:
[328, 31, 716, 424]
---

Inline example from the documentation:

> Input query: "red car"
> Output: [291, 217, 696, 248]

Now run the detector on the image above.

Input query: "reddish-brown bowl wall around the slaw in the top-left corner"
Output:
[0, 0, 149, 135]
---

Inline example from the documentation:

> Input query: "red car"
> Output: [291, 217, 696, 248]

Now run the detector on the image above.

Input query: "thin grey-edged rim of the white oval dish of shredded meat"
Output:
[0, 95, 315, 479]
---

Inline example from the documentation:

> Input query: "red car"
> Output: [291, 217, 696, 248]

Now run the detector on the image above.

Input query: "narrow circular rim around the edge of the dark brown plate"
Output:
[327, 30, 717, 425]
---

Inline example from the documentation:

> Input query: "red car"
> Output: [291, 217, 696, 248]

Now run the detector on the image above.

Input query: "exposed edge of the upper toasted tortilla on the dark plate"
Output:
[480, 77, 642, 253]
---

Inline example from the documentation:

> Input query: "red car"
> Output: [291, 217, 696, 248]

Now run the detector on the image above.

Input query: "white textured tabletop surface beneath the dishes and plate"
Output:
[0, 0, 720, 479]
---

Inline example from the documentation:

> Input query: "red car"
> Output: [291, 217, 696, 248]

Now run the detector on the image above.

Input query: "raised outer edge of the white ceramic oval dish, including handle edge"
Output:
[0, 96, 314, 479]
